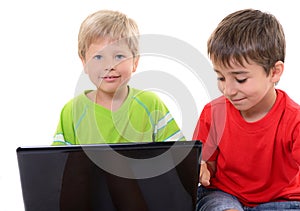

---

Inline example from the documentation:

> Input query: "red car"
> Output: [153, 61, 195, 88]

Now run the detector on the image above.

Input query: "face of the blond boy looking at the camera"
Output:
[82, 39, 138, 94]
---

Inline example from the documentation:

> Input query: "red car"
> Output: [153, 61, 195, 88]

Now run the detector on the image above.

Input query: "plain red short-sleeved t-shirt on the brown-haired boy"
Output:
[193, 90, 300, 206]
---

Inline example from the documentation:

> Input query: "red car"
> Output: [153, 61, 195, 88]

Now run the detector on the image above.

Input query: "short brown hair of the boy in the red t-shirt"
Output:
[207, 9, 286, 75]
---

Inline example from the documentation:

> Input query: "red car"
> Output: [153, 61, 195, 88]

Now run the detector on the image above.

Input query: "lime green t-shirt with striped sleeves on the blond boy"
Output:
[52, 88, 185, 145]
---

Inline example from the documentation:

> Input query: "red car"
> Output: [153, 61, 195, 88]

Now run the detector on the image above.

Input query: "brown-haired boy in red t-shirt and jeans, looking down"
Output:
[193, 9, 300, 211]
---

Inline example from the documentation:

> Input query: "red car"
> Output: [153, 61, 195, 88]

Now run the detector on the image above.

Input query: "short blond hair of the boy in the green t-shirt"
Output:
[78, 10, 139, 59]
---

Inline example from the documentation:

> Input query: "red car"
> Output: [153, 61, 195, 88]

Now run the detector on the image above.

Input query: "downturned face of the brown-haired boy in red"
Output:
[214, 62, 283, 118]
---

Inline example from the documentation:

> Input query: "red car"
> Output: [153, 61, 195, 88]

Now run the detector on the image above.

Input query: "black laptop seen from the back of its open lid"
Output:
[17, 141, 202, 211]
